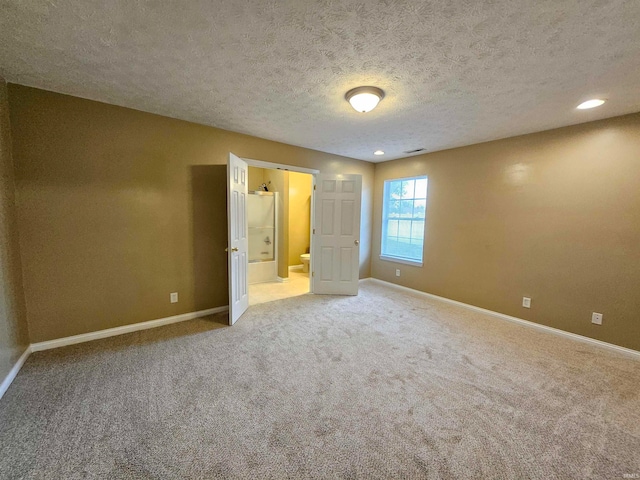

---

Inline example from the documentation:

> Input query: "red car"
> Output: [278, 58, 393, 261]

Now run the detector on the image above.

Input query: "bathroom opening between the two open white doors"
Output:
[247, 160, 313, 305]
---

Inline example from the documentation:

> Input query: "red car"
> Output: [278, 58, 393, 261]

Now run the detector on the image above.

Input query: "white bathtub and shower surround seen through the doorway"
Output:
[247, 191, 278, 284]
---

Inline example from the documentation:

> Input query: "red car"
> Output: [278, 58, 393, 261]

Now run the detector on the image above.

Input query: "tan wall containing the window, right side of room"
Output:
[372, 114, 640, 350]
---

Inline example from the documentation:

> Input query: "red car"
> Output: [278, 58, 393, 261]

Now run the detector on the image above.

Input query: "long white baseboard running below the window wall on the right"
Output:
[363, 278, 640, 360]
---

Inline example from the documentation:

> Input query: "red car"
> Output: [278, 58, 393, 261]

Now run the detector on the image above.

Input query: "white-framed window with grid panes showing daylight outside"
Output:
[380, 177, 427, 265]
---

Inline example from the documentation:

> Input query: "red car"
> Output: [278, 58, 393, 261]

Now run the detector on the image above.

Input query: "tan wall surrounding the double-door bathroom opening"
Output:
[9, 85, 374, 342]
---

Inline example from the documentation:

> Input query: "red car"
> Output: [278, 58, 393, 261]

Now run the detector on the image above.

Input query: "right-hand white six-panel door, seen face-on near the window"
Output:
[311, 174, 362, 295]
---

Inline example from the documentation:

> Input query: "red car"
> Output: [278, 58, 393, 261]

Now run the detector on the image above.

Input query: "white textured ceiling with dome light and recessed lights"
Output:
[0, 0, 640, 162]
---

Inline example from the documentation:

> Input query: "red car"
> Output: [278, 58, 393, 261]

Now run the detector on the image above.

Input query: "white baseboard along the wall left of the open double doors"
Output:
[31, 305, 229, 352]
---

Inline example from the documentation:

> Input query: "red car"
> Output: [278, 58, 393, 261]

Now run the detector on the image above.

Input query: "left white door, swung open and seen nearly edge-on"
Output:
[227, 153, 249, 325]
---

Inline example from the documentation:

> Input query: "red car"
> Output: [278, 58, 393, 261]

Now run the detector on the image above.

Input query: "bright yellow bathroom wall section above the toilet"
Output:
[288, 172, 313, 266]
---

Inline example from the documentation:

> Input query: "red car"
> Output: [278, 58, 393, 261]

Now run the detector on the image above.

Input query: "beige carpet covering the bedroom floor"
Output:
[0, 282, 640, 480]
